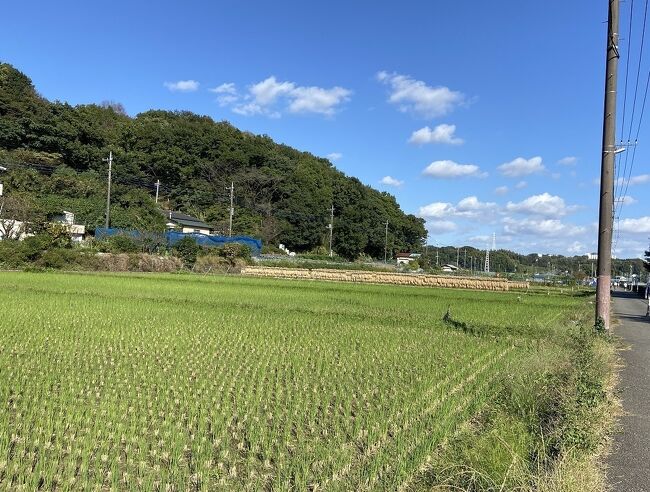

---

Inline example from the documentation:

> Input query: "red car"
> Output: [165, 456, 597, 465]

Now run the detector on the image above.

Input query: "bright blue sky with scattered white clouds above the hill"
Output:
[0, 0, 650, 257]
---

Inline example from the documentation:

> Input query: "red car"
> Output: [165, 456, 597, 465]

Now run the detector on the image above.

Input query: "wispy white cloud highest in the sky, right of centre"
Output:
[377, 72, 465, 118]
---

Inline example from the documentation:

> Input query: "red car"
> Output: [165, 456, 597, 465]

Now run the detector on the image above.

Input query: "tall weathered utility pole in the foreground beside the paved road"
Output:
[596, 0, 619, 330]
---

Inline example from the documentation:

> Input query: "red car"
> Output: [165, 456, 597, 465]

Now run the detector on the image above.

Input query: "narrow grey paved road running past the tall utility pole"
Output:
[607, 292, 650, 492]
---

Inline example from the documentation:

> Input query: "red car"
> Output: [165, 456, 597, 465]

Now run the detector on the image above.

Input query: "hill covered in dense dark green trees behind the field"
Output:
[0, 64, 426, 258]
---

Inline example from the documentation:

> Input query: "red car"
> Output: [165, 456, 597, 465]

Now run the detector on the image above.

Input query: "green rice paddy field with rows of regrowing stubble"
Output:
[0, 272, 586, 490]
